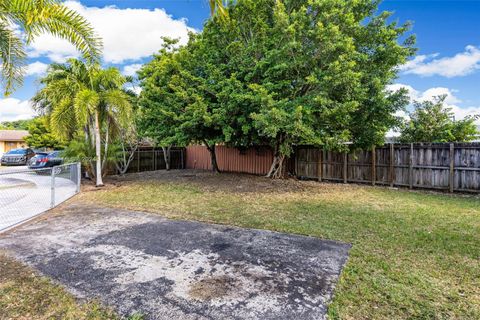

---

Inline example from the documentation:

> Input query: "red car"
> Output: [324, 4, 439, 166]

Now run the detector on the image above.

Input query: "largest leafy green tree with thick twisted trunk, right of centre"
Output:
[201, 0, 414, 177]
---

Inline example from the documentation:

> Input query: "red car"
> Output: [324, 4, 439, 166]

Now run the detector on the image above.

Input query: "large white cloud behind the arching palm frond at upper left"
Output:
[29, 1, 194, 63]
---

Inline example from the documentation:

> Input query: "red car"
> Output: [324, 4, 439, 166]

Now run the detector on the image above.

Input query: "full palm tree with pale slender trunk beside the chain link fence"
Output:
[33, 59, 132, 186]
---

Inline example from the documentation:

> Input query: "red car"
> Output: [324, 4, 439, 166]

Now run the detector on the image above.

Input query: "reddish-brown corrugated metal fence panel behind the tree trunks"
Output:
[186, 145, 273, 175]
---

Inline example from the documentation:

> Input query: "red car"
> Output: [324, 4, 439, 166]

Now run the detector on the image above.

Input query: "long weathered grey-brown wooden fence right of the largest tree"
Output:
[295, 143, 480, 192]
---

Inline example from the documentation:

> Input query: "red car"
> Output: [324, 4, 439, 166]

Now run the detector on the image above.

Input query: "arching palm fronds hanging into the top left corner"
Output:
[0, 0, 101, 95]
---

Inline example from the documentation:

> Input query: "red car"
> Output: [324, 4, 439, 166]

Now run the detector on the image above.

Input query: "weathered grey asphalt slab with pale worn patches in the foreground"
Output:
[0, 205, 350, 320]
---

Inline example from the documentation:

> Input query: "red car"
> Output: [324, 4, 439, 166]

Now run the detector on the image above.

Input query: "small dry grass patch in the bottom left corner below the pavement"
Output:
[0, 253, 118, 320]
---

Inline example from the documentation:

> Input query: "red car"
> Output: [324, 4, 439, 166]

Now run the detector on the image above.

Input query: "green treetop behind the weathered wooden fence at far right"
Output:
[399, 96, 479, 143]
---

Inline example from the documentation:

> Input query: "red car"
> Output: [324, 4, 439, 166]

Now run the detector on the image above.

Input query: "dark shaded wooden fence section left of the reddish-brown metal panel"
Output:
[127, 148, 185, 173]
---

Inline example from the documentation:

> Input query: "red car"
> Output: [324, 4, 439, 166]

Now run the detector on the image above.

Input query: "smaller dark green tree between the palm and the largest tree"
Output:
[139, 35, 224, 172]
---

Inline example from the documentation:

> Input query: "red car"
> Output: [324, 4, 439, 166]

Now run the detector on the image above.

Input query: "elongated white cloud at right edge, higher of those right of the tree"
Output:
[400, 46, 480, 78]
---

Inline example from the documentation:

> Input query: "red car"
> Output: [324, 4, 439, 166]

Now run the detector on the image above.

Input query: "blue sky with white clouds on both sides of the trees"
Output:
[0, 0, 480, 121]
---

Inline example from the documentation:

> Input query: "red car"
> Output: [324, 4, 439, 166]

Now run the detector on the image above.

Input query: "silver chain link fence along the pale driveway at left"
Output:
[0, 163, 81, 232]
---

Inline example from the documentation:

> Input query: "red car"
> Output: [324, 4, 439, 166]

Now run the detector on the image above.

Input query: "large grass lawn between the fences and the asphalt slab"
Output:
[79, 172, 480, 319]
